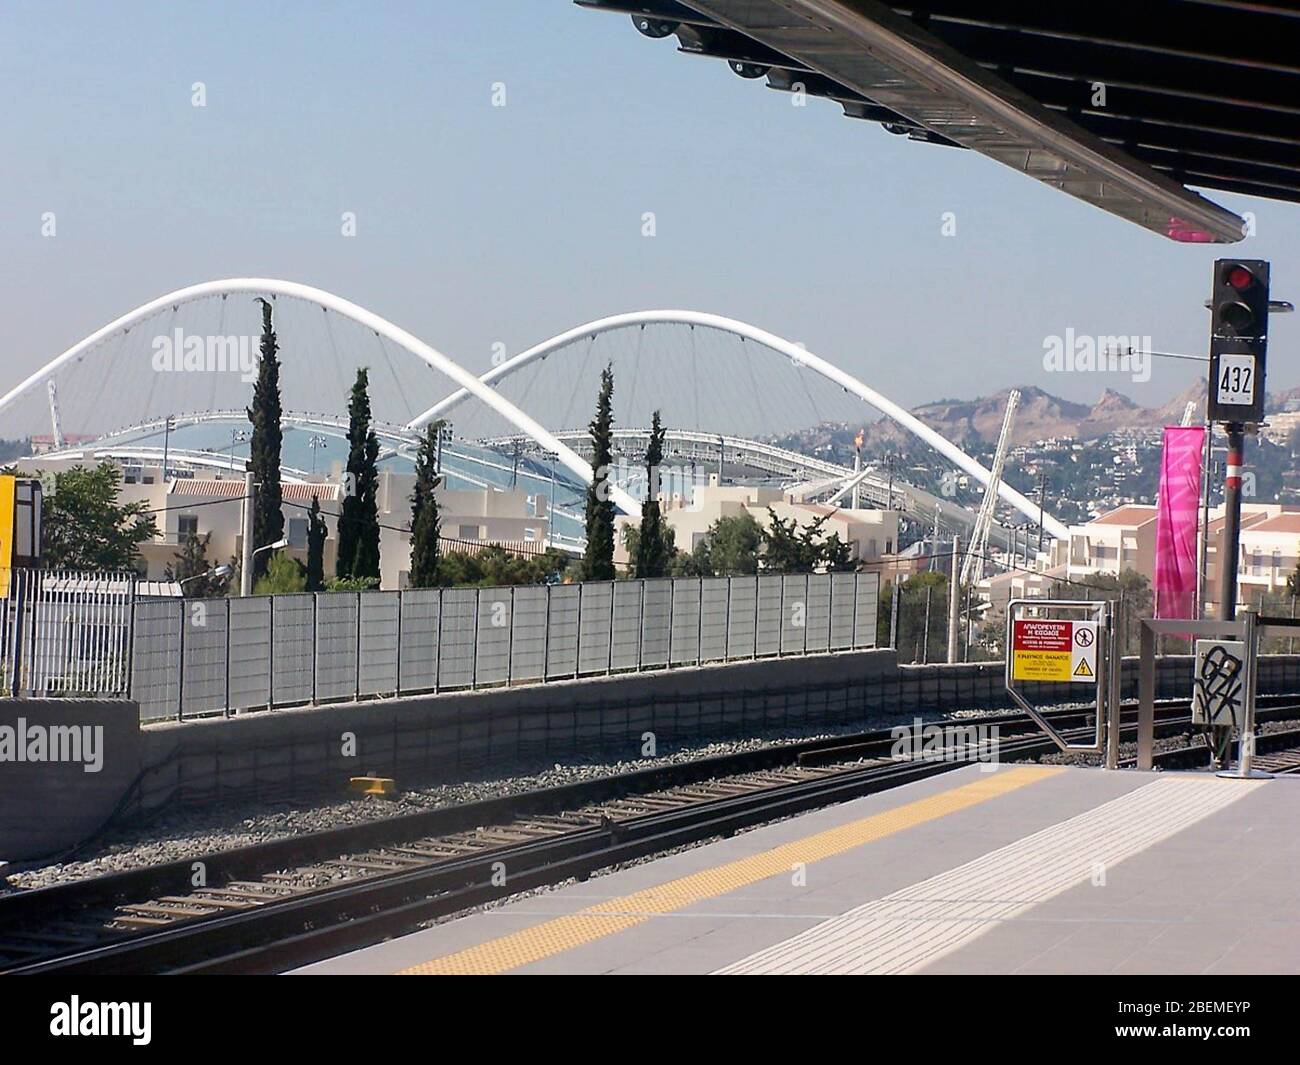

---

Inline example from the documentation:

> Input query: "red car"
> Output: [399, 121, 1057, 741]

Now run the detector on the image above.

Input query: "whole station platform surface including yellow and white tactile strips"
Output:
[298, 765, 1300, 975]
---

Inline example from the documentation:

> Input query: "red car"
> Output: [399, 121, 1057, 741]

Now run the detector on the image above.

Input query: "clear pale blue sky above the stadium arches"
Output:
[0, 0, 1300, 416]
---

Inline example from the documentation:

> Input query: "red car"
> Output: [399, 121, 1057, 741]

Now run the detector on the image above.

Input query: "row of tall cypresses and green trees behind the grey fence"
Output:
[25, 298, 854, 597]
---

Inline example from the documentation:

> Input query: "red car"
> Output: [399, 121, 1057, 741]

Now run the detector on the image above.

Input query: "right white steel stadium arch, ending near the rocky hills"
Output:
[407, 311, 1070, 540]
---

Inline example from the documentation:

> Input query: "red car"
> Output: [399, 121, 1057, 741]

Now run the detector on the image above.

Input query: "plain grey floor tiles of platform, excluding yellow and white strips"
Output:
[300, 767, 1300, 974]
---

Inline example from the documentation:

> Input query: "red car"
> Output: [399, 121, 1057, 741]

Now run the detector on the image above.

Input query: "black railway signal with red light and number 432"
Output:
[1208, 259, 1269, 424]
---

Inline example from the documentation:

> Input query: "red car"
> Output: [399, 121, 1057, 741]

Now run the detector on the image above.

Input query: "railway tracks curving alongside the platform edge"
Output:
[0, 698, 1295, 974]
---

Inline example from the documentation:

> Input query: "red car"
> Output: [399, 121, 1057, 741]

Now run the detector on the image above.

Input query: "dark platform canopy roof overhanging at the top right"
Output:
[575, 0, 1300, 243]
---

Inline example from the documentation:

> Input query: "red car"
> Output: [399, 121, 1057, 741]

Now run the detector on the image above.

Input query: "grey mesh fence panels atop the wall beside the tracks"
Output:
[131, 573, 880, 720]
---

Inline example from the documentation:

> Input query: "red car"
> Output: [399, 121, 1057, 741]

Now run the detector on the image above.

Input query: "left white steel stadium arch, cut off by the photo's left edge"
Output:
[8, 277, 641, 514]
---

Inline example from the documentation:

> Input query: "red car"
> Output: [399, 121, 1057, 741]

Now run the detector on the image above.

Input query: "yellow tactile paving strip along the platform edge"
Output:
[400, 766, 1063, 977]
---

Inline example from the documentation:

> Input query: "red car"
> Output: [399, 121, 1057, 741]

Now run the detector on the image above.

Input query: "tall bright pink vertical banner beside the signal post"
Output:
[1156, 427, 1205, 618]
